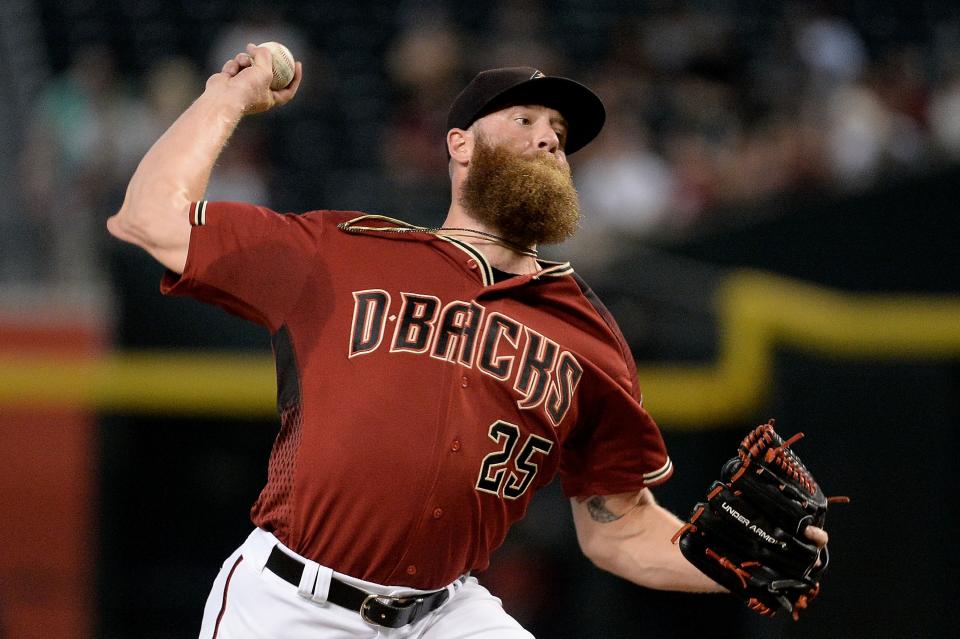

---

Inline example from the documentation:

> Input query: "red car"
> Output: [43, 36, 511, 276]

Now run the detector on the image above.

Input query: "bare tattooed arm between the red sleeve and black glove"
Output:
[574, 491, 724, 592]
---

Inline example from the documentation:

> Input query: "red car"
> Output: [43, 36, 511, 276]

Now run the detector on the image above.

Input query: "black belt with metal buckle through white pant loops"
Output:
[266, 546, 450, 628]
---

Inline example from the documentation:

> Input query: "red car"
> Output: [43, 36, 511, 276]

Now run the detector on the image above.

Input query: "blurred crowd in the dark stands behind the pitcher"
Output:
[0, 0, 960, 283]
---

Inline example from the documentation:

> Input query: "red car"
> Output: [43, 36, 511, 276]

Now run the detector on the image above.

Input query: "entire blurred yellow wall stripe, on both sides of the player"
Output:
[0, 271, 960, 428]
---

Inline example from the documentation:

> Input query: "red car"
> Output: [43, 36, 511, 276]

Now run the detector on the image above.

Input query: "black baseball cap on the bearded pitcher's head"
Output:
[447, 67, 607, 155]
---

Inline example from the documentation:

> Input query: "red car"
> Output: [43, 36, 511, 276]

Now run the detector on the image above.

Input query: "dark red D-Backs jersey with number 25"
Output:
[161, 202, 672, 589]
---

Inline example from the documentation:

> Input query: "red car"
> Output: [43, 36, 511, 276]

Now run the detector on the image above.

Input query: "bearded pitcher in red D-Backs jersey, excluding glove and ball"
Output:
[108, 45, 824, 639]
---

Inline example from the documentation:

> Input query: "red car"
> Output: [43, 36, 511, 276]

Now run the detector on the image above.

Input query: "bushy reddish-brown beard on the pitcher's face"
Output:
[460, 136, 580, 247]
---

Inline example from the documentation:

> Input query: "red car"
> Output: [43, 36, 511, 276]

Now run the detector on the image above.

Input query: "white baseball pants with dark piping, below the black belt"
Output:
[200, 528, 533, 639]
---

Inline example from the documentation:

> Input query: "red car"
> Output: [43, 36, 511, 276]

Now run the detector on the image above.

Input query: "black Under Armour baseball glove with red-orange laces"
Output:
[673, 420, 849, 619]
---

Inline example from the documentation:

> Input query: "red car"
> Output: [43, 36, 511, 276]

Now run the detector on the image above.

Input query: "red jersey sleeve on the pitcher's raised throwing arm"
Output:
[160, 201, 323, 333]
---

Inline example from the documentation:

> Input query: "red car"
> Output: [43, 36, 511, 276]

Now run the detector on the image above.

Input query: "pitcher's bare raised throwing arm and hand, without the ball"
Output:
[107, 44, 302, 273]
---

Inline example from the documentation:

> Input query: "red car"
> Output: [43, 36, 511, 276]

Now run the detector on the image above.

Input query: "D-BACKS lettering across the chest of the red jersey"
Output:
[349, 289, 583, 427]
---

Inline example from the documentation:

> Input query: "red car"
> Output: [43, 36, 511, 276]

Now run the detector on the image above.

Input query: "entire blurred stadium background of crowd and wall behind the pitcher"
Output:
[0, 0, 960, 639]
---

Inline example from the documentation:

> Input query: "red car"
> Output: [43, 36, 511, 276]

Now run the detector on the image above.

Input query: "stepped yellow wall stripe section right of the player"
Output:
[638, 271, 960, 428]
